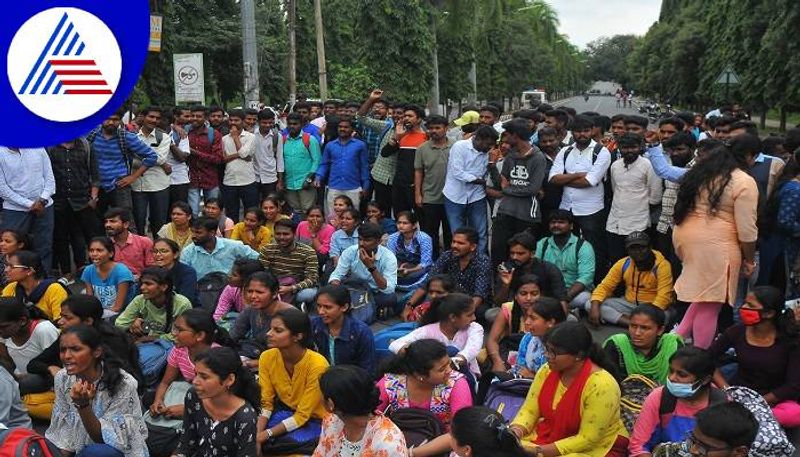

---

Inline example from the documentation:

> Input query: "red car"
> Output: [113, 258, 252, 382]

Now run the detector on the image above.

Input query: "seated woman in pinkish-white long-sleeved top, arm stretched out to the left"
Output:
[389, 293, 483, 379]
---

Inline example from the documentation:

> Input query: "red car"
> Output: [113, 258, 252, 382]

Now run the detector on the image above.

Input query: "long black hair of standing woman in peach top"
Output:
[673, 135, 760, 224]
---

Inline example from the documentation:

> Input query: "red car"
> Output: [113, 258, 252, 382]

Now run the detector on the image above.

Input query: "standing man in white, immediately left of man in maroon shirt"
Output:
[161, 106, 192, 208]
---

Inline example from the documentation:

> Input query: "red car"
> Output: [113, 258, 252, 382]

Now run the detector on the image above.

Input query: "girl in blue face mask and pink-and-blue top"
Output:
[628, 347, 726, 457]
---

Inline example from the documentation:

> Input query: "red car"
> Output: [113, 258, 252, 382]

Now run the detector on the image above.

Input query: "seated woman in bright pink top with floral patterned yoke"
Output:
[378, 339, 472, 457]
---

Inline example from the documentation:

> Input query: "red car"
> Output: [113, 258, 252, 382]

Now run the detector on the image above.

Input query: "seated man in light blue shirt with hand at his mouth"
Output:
[330, 222, 397, 318]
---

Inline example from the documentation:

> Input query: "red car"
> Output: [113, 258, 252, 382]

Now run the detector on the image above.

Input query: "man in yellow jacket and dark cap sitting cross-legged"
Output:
[586, 232, 673, 326]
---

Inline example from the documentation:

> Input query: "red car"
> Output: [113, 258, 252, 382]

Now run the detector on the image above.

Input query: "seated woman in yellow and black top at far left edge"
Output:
[2, 251, 68, 322]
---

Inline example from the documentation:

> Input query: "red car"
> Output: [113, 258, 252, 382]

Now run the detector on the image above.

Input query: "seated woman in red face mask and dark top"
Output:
[709, 286, 800, 428]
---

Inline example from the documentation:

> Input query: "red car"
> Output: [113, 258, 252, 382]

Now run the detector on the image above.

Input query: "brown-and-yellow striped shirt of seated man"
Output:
[259, 241, 319, 290]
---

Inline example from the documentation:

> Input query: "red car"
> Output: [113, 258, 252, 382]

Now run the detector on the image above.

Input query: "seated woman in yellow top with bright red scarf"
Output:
[511, 322, 628, 457]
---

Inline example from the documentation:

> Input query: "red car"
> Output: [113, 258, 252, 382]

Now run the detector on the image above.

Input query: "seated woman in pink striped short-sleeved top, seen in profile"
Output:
[150, 308, 233, 430]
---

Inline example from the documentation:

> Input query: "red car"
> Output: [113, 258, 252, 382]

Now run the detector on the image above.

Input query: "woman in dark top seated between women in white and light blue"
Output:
[486, 274, 542, 372]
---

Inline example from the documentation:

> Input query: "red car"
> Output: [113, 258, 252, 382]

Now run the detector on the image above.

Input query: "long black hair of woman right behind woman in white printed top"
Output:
[61, 295, 147, 393]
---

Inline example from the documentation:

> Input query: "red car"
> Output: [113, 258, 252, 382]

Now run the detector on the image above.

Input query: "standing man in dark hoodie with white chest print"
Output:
[492, 119, 547, 265]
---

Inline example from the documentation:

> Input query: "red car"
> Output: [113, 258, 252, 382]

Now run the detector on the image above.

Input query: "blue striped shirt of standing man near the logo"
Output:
[92, 132, 158, 191]
